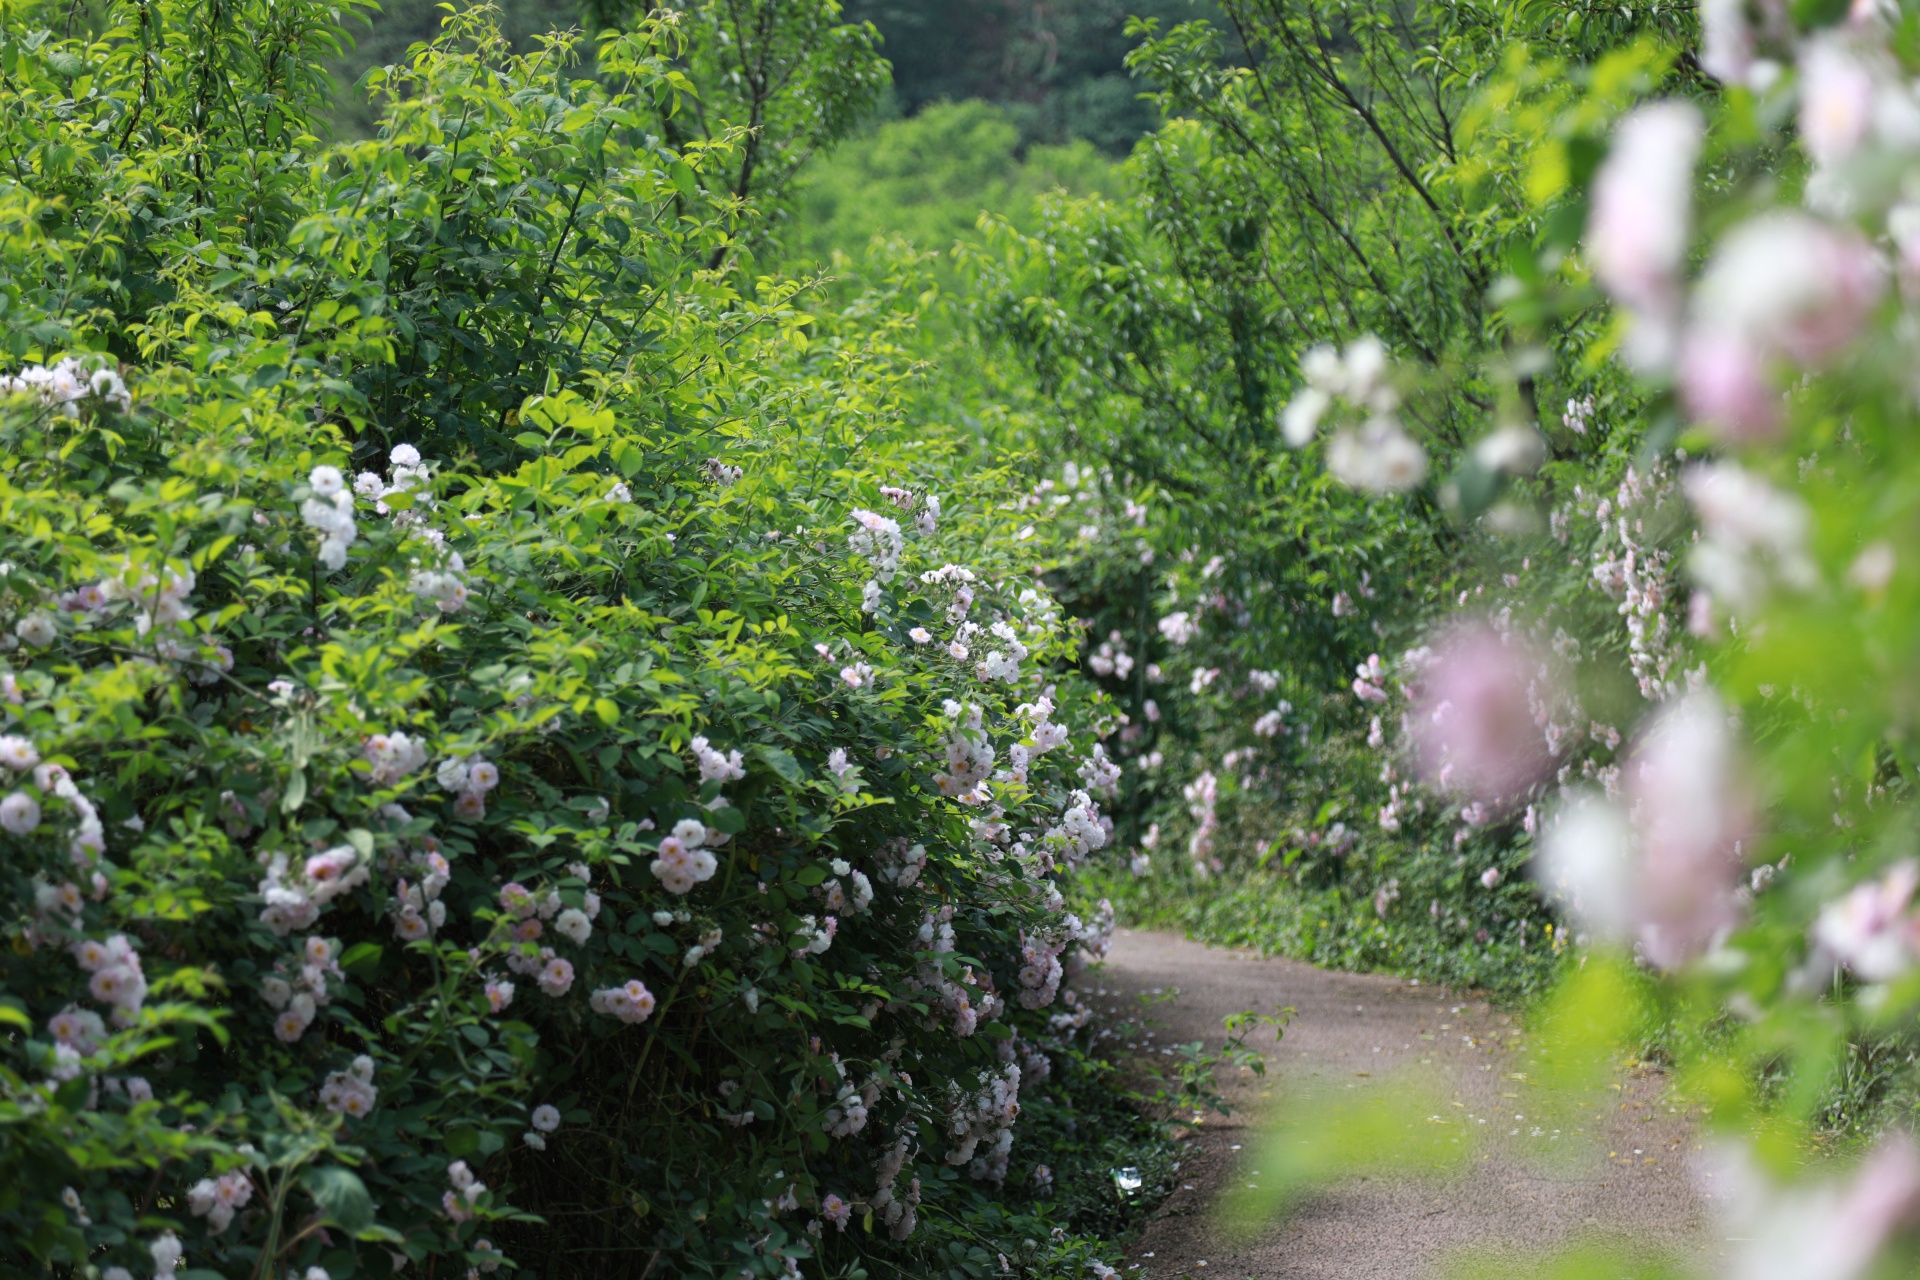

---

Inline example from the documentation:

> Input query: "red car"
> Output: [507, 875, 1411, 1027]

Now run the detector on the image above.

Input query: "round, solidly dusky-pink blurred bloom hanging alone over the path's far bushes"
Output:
[1411, 624, 1557, 804]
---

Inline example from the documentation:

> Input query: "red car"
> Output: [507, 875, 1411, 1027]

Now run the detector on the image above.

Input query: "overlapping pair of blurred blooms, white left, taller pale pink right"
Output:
[1540, 691, 1753, 969]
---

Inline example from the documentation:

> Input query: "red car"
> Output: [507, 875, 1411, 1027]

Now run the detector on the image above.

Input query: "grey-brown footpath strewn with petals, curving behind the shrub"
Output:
[1091, 929, 1726, 1280]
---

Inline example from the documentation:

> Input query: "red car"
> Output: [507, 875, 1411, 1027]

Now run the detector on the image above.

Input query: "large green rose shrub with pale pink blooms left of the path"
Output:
[0, 0, 1152, 1276]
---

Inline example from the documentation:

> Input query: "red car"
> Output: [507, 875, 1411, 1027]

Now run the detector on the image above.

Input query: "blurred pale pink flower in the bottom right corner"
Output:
[1701, 1132, 1920, 1280]
